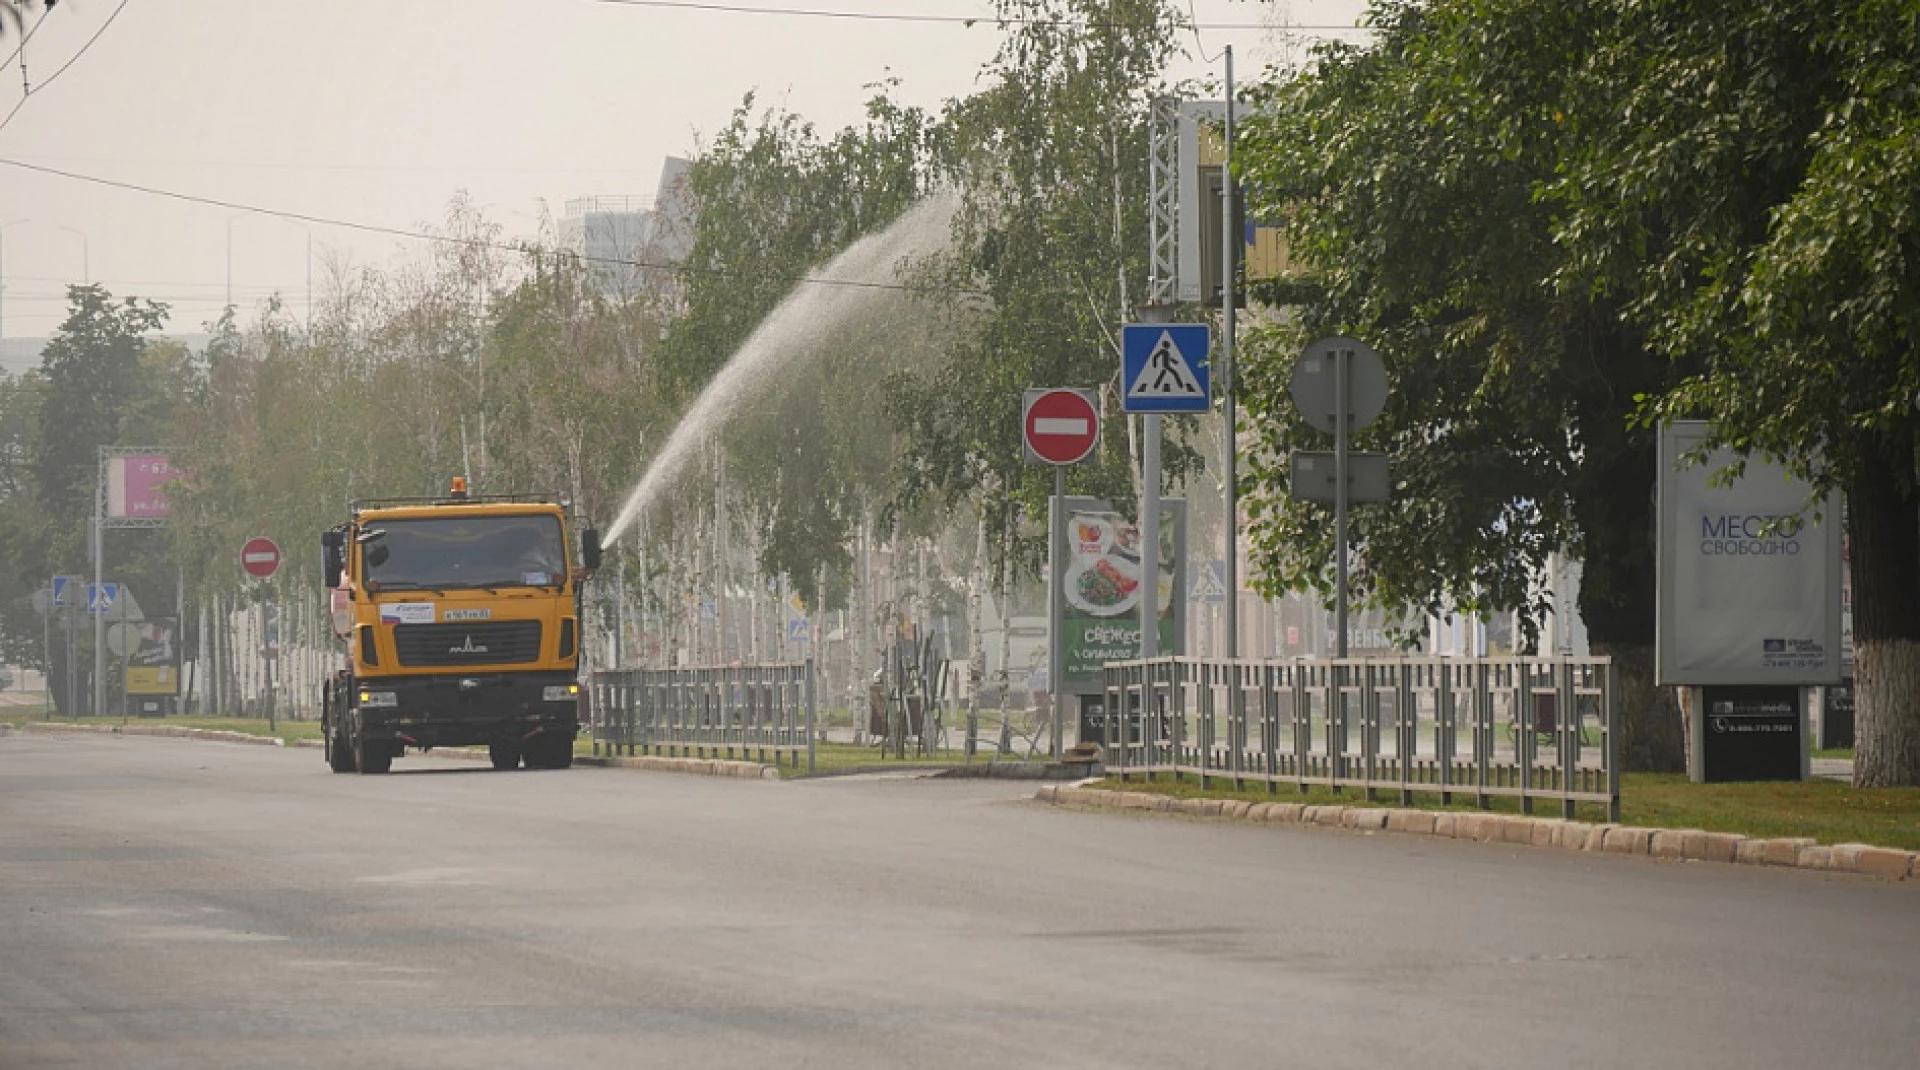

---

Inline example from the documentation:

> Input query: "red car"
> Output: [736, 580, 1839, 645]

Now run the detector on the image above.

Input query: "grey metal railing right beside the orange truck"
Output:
[589, 661, 816, 772]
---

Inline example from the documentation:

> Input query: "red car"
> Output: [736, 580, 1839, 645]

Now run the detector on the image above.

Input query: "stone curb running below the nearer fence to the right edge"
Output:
[1033, 784, 1920, 882]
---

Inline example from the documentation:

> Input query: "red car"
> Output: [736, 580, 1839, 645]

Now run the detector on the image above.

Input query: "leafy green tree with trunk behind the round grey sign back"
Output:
[1240, 0, 1682, 768]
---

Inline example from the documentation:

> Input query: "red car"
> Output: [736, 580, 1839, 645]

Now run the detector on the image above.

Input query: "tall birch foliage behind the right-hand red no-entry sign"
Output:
[887, 0, 1196, 546]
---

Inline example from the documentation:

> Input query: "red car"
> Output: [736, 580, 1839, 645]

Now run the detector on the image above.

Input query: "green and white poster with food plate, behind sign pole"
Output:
[1060, 498, 1187, 693]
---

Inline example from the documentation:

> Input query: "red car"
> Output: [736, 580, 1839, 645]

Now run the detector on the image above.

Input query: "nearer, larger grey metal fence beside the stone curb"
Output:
[1105, 657, 1620, 820]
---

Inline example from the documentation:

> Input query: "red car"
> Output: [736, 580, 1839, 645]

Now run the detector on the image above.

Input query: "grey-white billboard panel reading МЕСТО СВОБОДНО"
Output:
[1655, 421, 1841, 686]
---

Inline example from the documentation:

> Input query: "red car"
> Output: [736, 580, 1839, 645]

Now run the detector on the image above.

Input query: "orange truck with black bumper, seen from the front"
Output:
[321, 480, 599, 772]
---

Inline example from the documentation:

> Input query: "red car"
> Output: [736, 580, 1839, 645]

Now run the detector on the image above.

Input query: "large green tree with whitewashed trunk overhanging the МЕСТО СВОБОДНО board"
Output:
[1548, 0, 1920, 788]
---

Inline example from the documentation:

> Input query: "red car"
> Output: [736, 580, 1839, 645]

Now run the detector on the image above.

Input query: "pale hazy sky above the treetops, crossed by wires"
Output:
[0, 0, 1365, 338]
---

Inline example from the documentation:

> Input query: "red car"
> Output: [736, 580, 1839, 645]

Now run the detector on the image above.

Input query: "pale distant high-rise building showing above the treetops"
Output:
[559, 156, 693, 302]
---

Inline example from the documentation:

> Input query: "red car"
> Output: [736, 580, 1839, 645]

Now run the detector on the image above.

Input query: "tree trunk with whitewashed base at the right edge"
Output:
[1847, 434, 1920, 788]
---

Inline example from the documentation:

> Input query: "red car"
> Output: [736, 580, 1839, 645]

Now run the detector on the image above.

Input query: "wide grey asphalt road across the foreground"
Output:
[0, 734, 1920, 1070]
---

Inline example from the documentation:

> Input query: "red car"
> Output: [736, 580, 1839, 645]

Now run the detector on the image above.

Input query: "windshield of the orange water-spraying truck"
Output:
[359, 515, 566, 590]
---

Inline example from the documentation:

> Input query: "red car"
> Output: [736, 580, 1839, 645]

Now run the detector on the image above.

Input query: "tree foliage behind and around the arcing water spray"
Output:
[652, 85, 929, 605]
